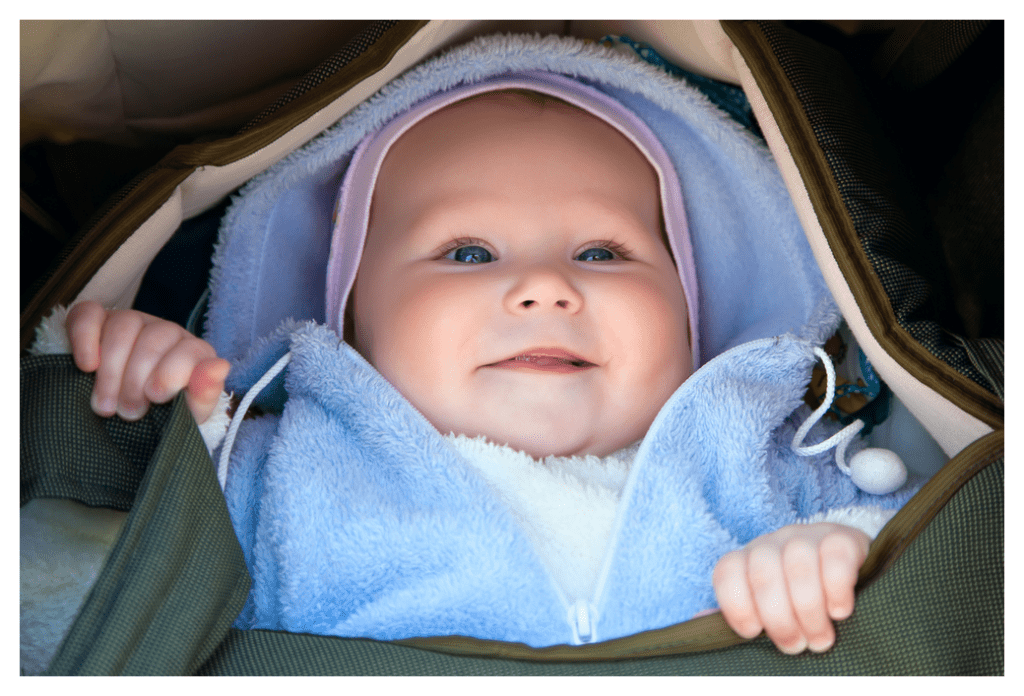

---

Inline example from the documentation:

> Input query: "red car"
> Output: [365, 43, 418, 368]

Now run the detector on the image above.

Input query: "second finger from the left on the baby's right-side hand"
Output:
[746, 545, 807, 655]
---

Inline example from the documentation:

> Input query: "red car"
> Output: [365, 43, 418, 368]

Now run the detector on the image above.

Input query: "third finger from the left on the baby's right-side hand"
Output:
[782, 536, 836, 652]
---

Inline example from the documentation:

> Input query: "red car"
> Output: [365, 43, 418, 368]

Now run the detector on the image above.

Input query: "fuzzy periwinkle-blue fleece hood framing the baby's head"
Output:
[205, 35, 838, 382]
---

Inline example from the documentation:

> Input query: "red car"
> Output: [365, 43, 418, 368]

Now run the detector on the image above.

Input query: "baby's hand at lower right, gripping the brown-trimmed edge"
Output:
[713, 522, 870, 655]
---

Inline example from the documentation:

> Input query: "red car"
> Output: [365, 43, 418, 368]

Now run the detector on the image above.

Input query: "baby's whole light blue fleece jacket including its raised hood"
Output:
[206, 36, 929, 646]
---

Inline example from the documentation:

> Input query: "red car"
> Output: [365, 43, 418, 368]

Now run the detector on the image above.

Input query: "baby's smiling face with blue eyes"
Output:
[349, 94, 692, 458]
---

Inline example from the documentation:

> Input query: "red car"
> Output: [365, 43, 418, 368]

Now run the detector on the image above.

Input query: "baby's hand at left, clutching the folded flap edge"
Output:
[67, 302, 230, 424]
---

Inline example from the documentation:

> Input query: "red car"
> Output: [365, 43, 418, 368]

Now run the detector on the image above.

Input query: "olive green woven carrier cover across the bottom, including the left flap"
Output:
[22, 355, 1004, 675]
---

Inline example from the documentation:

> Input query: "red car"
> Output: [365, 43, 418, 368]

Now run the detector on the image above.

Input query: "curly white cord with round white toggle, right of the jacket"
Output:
[793, 347, 906, 495]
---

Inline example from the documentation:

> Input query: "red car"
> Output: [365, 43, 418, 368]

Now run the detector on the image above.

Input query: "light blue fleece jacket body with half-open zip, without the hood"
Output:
[225, 322, 916, 646]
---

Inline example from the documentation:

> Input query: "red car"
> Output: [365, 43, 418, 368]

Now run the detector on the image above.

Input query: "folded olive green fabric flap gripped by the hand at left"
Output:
[20, 355, 250, 675]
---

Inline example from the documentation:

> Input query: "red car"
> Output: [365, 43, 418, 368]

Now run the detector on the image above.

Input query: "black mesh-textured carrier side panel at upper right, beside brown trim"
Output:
[758, 21, 1001, 393]
